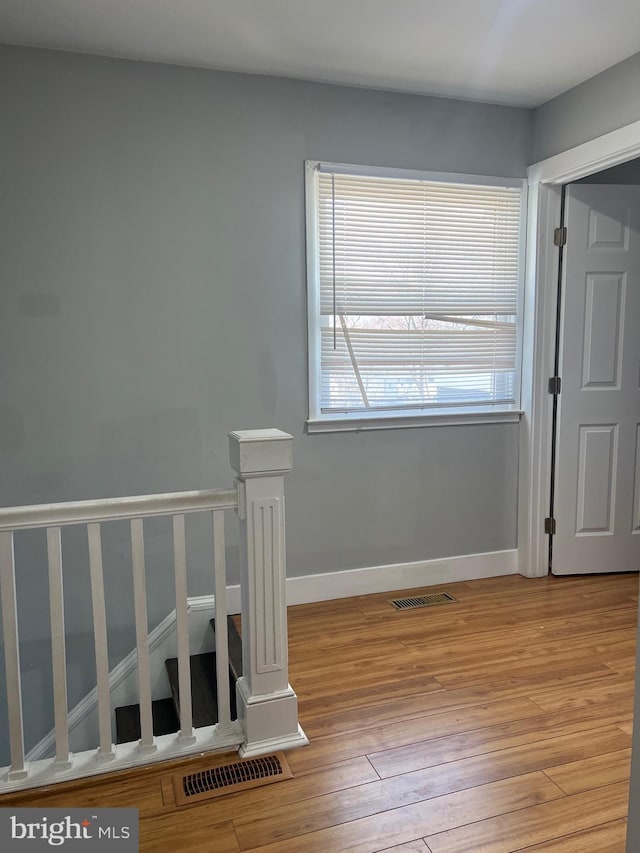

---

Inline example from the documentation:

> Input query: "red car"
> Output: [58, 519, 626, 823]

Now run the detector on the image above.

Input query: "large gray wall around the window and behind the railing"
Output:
[0, 47, 531, 756]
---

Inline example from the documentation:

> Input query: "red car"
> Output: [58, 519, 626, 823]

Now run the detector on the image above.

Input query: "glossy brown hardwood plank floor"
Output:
[0, 575, 638, 853]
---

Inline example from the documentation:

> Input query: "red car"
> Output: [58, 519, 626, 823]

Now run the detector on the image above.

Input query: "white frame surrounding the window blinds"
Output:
[305, 160, 528, 433]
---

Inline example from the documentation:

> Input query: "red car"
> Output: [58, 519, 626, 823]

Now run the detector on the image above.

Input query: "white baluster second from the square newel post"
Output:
[173, 514, 195, 744]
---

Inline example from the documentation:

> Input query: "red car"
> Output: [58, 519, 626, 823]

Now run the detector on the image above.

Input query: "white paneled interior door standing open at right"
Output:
[552, 184, 640, 574]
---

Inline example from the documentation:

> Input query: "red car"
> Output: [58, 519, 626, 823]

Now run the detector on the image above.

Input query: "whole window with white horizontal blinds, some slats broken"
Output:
[307, 161, 525, 431]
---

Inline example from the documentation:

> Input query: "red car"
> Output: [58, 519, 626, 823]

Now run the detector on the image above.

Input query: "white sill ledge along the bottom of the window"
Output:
[307, 409, 522, 434]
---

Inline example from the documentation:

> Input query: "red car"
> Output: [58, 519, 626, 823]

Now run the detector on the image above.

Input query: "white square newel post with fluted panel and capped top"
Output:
[229, 429, 308, 757]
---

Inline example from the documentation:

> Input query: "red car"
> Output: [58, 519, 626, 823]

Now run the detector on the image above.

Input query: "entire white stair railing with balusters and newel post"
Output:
[0, 430, 307, 792]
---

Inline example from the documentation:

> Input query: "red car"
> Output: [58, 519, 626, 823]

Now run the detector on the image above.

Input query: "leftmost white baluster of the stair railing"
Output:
[0, 532, 28, 779]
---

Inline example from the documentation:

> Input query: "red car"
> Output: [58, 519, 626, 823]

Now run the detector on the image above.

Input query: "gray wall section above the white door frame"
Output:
[532, 53, 640, 162]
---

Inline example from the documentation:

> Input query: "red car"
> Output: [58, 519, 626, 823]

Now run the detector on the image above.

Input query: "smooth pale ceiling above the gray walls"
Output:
[0, 0, 640, 107]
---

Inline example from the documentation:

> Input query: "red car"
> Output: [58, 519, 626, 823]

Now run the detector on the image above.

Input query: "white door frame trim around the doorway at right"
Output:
[518, 116, 640, 577]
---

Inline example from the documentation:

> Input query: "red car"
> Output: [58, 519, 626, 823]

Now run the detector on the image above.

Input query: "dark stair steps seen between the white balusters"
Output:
[115, 616, 242, 743]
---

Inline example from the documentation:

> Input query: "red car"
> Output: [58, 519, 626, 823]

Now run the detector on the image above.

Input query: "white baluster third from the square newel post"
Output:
[131, 518, 157, 753]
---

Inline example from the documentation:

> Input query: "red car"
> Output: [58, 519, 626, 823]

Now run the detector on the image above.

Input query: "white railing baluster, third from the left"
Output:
[87, 523, 115, 760]
